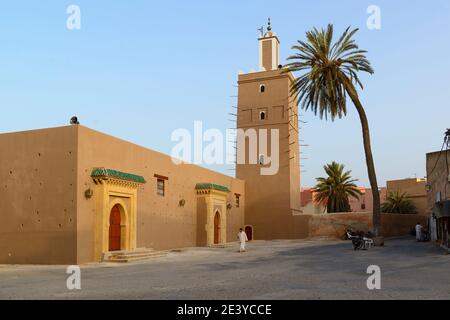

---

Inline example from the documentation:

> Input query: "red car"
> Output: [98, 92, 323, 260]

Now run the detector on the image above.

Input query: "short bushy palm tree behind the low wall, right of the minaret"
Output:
[315, 161, 362, 213]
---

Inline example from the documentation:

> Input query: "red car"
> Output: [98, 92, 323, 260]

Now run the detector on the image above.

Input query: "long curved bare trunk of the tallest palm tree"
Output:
[345, 82, 381, 237]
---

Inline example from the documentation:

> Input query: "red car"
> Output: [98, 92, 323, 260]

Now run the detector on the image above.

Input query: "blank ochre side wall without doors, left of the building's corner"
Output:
[0, 127, 77, 264]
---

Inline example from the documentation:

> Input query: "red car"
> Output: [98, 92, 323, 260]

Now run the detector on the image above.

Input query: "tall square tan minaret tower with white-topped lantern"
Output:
[236, 19, 307, 239]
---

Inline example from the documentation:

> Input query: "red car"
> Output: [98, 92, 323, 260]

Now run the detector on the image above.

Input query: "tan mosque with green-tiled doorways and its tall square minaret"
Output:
[0, 24, 308, 264]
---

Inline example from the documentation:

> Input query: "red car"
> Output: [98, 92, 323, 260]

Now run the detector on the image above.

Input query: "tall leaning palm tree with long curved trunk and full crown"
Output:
[285, 25, 381, 236]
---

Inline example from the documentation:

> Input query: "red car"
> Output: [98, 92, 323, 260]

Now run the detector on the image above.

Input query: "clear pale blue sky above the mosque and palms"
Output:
[0, 0, 450, 186]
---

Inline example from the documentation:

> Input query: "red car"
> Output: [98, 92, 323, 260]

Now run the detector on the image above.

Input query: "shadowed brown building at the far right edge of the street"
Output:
[426, 150, 450, 249]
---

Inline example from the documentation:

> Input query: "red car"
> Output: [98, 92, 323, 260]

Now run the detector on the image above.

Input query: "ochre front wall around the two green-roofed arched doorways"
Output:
[78, 126, 246, 263]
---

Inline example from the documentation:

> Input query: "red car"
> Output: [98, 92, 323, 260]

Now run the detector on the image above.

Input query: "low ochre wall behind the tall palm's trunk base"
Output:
[309, 212, 427, 238]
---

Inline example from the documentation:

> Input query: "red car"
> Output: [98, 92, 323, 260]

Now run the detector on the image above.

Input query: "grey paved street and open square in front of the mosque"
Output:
[0, 238, 450, 299]
